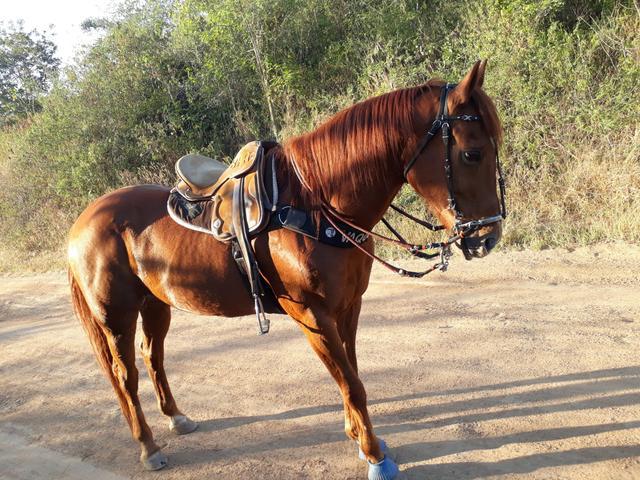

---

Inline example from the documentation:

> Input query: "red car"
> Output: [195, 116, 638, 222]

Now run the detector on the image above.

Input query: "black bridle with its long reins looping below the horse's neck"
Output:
[302, 83, 507, 278]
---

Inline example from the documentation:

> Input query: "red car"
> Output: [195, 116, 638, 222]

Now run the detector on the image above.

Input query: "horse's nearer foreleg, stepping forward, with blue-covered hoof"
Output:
[294, 308, 398, 480]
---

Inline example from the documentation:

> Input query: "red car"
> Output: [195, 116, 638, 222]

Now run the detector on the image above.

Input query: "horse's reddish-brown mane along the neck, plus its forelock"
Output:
[281, 80, 502, 210]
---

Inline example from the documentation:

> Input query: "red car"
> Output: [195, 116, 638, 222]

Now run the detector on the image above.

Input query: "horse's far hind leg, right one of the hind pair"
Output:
[140, 295, 198, 435]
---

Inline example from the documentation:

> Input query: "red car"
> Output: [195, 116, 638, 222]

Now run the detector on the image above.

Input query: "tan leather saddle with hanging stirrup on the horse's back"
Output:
[167, 142, 278, 335]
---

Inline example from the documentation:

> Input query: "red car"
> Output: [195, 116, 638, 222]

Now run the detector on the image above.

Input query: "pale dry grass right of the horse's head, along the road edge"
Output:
[504, 129, 640, 248]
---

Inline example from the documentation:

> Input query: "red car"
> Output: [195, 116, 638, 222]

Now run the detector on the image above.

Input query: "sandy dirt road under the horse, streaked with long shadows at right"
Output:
[0, 245, 640, 480]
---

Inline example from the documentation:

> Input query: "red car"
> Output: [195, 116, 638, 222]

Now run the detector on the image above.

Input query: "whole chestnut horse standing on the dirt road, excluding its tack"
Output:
[68, 62, 501, 479]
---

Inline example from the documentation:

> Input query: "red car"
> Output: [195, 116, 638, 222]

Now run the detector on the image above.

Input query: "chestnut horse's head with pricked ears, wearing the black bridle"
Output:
[404, 62, 506, 260]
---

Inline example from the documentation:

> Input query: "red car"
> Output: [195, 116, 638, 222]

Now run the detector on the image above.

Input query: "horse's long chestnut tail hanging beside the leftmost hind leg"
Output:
[68, 269, 131, 424]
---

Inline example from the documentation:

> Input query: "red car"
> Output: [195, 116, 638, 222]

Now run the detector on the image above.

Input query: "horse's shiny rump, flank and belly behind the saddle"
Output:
[68, 185, 252, 316]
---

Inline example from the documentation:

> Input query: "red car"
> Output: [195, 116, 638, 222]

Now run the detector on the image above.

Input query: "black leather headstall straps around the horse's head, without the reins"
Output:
[403, 83, 507, 237]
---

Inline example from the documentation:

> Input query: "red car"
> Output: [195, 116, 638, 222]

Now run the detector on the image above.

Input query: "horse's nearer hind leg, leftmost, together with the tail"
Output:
[70, 274, 167, 470]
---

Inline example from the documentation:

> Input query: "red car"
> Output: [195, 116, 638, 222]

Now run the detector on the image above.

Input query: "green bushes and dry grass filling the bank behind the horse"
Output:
[0, 0, 640, 266]
